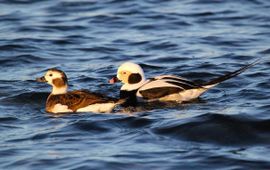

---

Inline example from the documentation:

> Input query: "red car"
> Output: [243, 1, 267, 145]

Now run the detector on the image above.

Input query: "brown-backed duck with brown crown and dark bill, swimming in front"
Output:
[36, 68, 121, 113]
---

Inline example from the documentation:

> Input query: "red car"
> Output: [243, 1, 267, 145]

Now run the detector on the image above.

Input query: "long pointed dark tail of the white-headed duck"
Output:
[202, 60, 260, 89]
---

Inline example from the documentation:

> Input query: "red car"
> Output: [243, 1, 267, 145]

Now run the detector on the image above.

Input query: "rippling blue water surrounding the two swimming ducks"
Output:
[0, 0, 270, 170]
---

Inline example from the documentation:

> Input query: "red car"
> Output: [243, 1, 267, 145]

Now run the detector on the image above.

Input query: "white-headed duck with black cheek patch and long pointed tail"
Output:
[109, 62, 257, 106]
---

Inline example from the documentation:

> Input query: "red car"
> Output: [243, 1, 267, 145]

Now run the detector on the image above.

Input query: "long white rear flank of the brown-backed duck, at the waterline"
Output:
[77, 103, 116, 113]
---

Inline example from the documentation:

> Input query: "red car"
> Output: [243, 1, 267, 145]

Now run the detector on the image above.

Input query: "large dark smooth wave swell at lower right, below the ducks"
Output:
[153, 113, 270, 145]
